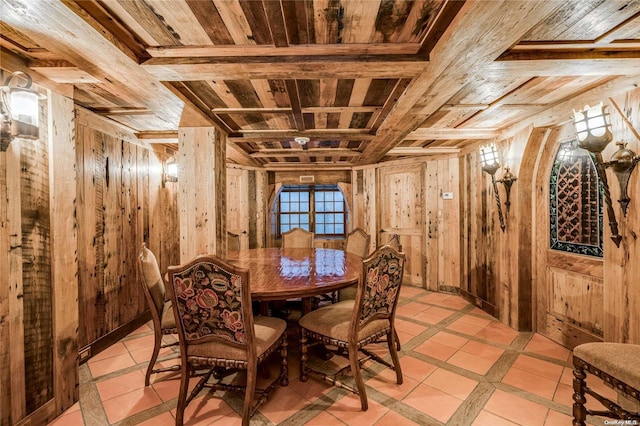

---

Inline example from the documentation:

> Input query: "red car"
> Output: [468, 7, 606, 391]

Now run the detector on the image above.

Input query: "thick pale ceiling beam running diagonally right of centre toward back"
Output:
[357, 0, 558, 165]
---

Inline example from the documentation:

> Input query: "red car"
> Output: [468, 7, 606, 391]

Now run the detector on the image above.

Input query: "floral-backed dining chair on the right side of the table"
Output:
[299, 246, 404, 411]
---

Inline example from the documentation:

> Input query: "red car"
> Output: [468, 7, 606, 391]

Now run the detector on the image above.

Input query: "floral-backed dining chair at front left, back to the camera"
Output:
[167, 255, 289, 426]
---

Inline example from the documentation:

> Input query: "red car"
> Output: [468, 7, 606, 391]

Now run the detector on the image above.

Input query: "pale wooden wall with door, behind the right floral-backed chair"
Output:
[351, 157, 463, 293]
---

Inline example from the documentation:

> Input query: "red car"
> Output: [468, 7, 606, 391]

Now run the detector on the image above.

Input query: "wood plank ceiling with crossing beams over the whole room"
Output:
[0, 0, 640, 168]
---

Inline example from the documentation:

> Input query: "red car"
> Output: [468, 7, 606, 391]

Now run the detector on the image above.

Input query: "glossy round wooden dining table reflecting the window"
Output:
[227, 248, 362, 313]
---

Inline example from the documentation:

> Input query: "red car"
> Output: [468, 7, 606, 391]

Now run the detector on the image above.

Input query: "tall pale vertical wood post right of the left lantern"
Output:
[49, 92, 79, 414]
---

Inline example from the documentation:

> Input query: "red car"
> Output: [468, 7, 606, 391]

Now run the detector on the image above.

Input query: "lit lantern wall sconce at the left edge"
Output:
[0, 71, 46, 152]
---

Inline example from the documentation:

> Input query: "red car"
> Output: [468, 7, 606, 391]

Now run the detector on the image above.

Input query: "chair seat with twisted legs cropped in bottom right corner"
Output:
[573, 342, 640, 426]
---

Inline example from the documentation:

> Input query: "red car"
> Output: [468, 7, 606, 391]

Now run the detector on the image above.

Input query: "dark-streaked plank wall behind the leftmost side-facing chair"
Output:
[76, 114, 179, 347]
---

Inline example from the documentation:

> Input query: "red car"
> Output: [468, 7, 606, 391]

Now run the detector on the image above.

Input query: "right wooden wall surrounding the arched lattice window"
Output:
[461, 85, 640, 342]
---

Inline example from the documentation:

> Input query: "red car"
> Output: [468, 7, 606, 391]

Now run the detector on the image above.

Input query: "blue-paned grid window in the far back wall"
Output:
[274, 185, 347, 238]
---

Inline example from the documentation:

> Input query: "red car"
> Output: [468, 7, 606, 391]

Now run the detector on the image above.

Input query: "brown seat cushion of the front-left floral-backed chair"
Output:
[187, 316, 287, 361]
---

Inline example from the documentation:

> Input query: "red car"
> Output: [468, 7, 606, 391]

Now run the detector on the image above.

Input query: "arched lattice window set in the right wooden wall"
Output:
[549, 142, 603, 257]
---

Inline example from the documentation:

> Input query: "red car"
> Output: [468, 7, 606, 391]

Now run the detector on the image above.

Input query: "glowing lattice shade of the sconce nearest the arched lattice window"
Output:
[573, 102, 613, 153]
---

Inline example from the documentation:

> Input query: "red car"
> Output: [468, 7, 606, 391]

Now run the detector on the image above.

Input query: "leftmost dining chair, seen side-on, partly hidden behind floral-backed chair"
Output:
[138, 243, 180, 386]
